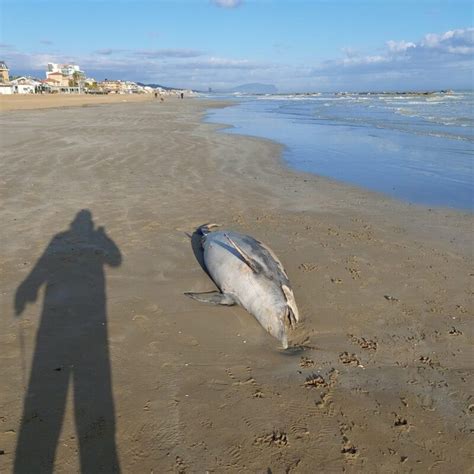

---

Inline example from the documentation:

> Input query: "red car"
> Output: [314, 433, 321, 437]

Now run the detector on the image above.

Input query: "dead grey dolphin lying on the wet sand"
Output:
[185, 224, 300, 349]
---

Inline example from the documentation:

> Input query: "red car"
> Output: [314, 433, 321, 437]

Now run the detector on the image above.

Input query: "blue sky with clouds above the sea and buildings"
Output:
[0, 0, 474, 92]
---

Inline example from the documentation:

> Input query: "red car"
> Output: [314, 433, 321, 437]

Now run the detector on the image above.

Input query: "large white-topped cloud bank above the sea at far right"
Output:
[311, 28, 474, 90]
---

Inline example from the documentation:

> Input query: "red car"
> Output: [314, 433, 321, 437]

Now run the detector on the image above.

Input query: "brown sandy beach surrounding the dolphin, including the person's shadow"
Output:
[0, 100, 474, 473]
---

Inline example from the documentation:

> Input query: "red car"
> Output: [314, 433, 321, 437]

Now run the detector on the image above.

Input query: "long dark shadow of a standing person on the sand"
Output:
[13, 210, 121, 474]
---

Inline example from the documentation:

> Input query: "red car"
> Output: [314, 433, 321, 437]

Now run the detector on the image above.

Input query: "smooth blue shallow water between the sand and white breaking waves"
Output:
[202, 92, 473, 213]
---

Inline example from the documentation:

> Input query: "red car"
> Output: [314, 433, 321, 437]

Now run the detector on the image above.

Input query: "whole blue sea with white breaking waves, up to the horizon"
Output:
[207, 91, 474, 212]
